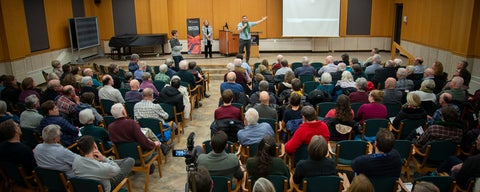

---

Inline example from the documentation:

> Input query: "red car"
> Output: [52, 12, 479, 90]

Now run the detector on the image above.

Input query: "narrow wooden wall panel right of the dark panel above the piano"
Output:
[134, 1, 151, 34]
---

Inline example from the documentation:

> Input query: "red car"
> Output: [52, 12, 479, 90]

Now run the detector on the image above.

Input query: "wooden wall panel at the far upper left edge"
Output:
[0, 0, 30, 61]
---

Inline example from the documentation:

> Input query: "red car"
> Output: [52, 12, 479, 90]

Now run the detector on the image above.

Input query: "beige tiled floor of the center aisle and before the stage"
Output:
[89, 52, 402, 191]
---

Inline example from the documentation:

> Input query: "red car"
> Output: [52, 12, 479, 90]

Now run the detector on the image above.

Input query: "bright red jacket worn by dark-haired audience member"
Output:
[285, 121, 330, 154]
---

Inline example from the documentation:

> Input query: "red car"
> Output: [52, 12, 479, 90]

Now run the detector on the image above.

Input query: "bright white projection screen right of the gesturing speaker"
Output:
[282, 0, 340, 37]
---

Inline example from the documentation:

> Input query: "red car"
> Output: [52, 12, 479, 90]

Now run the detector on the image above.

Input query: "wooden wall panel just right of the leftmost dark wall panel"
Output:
[44, 0, 73, 50]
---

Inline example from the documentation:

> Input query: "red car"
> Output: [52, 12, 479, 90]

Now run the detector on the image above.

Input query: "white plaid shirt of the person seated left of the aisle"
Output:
[133, 100, 168, 123]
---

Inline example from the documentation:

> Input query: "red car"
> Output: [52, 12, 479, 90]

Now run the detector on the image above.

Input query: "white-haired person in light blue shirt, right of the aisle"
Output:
[237, 108, 275, 145]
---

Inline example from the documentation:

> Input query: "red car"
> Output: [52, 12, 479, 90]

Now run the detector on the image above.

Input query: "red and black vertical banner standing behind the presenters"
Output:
[187, 18, 202, 54]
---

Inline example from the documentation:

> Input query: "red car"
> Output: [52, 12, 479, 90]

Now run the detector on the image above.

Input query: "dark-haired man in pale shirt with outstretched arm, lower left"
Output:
[72, 135, 135, 191]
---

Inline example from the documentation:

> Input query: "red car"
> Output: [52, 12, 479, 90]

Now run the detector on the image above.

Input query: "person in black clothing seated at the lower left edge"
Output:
[0, 120, 37, 175]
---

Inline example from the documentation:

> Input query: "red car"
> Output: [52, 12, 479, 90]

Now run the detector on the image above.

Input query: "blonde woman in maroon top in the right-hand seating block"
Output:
[357, 90, 387, 124]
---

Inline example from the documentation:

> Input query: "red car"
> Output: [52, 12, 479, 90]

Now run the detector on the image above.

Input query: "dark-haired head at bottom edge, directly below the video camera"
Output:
[188, 165, 213, 192]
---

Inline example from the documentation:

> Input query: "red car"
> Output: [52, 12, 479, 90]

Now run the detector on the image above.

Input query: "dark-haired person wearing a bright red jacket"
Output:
[285, 106, 330, 154]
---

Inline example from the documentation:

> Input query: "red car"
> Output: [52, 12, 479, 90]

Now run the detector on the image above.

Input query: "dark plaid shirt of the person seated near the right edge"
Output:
[415, 122, 463, 147]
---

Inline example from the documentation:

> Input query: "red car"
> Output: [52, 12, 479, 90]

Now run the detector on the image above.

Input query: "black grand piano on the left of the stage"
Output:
[108, 33, 167, 59]
